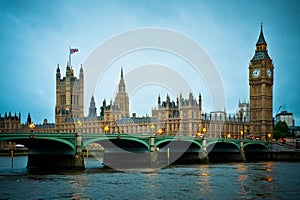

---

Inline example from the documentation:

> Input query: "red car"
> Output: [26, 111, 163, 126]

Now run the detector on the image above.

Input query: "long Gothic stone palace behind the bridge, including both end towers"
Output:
[0, 27, 274, 140]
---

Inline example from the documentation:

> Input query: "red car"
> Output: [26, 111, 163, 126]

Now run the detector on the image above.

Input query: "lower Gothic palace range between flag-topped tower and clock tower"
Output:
[52, 65, 249, 138]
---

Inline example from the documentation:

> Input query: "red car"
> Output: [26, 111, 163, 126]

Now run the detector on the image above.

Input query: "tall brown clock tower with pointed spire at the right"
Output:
[249, 25, 274, 140]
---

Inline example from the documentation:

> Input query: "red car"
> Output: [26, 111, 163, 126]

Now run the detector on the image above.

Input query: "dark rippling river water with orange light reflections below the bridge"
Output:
[0, 156, 300, 200]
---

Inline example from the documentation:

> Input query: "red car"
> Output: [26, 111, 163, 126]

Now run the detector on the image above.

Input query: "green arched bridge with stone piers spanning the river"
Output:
[0, 132, 270, 168]
